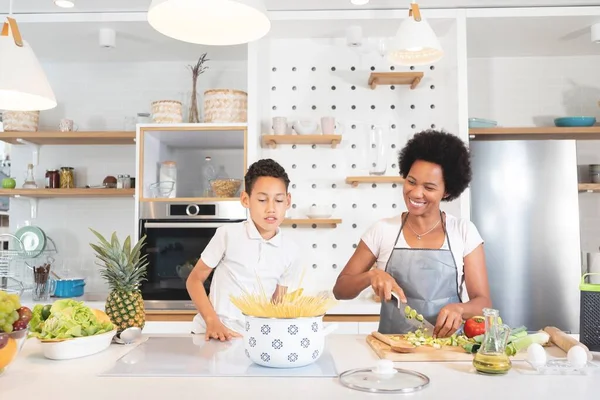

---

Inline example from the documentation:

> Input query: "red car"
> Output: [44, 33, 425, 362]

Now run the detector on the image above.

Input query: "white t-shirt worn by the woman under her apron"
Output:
[361, 213, 483, 302]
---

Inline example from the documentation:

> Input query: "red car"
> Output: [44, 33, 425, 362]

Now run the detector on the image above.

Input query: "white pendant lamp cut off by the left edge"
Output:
[0, 2, 57, 111]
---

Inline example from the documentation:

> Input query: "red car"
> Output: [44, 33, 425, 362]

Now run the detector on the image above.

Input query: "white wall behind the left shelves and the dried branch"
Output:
[10, 58, 247, 291]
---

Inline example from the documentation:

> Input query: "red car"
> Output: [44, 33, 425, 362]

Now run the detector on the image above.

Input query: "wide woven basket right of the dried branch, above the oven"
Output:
[204, 89, 248, 122]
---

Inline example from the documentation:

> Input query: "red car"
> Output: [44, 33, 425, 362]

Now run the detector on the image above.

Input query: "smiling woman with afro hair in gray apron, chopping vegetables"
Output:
[333, 131, 491, 337]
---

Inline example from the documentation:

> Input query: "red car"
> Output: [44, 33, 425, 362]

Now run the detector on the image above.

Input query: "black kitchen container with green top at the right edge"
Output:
[579, 272, 600, 351]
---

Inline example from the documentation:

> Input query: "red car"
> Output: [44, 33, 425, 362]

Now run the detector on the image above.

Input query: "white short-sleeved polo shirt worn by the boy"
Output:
[192, 219, 300, 333]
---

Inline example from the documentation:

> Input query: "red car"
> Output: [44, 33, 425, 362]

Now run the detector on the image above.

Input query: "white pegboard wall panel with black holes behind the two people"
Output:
[259, 29, 460, 290]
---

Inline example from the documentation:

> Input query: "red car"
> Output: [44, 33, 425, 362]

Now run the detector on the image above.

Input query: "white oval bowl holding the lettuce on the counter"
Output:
[42, 329, 117, 360]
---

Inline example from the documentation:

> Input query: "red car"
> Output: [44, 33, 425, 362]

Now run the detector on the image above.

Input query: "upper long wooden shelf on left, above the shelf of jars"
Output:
[0, 131, 135, 145]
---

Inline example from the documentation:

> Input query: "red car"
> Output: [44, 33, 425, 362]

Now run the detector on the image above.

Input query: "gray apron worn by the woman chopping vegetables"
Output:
[378, 211, 461, 334]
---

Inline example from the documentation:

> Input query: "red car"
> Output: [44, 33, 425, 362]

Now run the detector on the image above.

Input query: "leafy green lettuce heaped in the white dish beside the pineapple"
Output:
[29, 299, 114, 339]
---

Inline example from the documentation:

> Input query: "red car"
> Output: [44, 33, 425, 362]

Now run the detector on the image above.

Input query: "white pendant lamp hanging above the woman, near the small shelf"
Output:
[388, 0, 444, 65]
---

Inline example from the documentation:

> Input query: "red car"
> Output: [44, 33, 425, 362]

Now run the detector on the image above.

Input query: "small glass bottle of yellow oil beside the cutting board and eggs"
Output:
[473, 308, 512, 375]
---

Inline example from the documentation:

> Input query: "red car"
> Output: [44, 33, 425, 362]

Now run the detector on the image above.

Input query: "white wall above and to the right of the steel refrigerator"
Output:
[468, 56, 600, 260]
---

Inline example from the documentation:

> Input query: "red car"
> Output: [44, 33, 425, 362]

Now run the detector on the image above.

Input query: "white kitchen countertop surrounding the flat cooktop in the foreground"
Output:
[0, 335, 600, 400]
